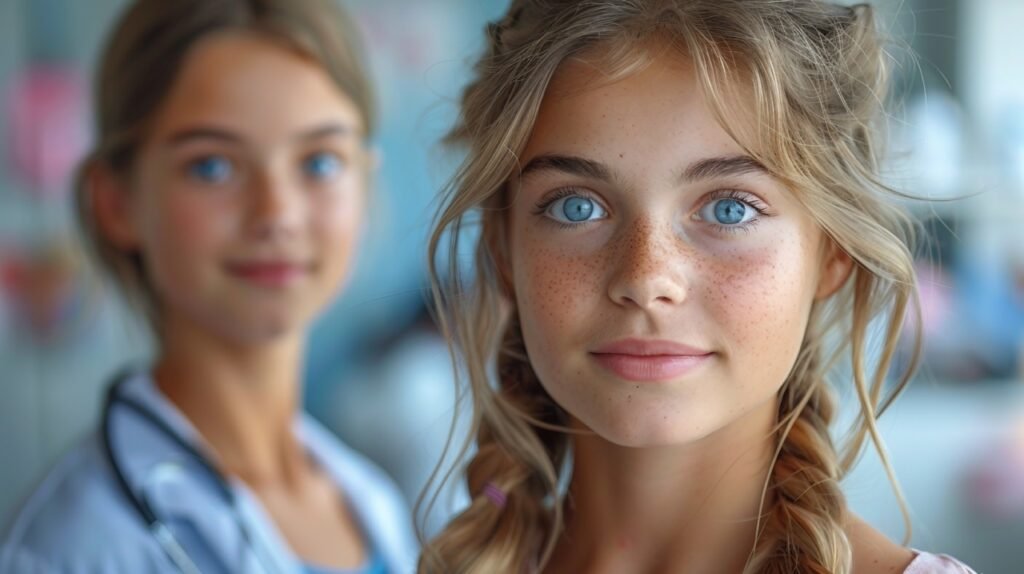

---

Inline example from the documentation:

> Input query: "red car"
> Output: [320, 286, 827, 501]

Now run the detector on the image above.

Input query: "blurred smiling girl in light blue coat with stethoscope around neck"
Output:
[0, 0, 416, 573]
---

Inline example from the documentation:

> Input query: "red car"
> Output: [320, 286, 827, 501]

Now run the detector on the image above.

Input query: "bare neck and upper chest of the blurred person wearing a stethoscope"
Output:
[154, 313, 307, 487]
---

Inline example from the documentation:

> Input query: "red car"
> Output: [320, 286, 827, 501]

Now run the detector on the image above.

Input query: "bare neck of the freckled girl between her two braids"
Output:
[548, 403, 775, 573]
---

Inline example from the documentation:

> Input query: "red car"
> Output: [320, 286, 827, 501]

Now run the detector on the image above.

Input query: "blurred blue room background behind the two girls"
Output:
[0, 0, 1024, 574]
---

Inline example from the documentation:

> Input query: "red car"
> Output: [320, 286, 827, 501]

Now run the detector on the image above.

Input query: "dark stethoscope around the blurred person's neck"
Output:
[100, 376, 284, 574]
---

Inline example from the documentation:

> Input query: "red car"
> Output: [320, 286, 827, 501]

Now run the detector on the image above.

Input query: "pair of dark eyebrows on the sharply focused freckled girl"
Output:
[519, 153, 771, 183]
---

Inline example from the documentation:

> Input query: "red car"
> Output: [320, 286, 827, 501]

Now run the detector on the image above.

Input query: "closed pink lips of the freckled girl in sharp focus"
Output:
[591, 339, 715, 382]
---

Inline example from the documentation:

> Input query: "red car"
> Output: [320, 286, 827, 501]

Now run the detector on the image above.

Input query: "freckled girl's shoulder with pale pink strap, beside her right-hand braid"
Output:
[846, 516, 975, 574]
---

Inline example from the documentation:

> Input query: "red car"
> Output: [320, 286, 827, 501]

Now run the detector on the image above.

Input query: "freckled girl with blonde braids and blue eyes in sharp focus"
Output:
[420, 0, 969, 574]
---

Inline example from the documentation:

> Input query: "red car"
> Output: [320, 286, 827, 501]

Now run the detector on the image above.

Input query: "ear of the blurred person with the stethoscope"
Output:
[85, 165, 139, 251]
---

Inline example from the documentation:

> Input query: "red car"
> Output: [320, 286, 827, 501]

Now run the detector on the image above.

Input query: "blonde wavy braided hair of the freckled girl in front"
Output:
[420, 0, 920, 574]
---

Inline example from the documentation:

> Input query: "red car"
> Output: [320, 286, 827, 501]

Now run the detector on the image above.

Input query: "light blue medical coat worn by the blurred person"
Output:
[0, 376, 418, 574]
